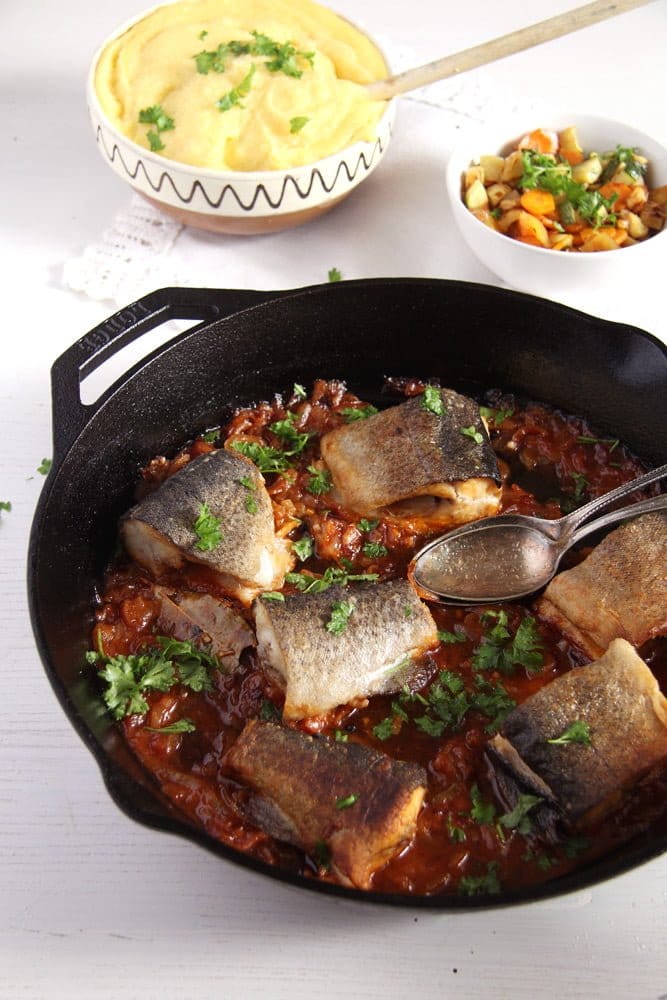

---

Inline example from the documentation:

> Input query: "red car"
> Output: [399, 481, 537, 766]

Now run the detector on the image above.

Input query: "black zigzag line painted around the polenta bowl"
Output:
[96, 125, 391, 212]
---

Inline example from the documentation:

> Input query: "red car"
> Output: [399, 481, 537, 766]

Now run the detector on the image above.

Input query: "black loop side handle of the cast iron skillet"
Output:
[51, 288, 286, 465]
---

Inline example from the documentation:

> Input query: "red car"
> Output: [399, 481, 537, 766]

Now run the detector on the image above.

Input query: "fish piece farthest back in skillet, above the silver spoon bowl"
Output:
[322, 389, 500, 525]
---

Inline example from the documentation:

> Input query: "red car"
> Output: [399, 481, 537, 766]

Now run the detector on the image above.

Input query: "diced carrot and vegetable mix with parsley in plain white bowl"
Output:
[463, 127, 667, 253]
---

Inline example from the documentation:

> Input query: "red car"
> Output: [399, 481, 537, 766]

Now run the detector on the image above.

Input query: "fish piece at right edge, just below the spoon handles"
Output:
[537, 511, 667, 657]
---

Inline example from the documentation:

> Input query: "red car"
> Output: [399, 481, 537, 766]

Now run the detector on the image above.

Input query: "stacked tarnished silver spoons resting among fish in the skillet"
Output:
[408, 465, 667, 604]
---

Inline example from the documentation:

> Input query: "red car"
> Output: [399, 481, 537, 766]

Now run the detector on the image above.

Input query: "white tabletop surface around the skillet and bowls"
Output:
[0, 0, 667, 1000]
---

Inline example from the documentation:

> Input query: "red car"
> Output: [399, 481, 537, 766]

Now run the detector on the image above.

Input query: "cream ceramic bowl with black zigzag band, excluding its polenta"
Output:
[86, 11, 396, 235]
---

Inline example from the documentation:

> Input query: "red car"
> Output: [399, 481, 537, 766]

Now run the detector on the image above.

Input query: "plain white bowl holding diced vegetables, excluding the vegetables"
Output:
[446, 111, 667, 298]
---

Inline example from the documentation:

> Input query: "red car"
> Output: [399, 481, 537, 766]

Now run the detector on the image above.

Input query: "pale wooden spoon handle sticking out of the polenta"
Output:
[366, 0, 652, 101]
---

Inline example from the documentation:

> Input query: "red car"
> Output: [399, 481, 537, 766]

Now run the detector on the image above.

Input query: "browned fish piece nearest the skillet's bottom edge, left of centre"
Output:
[225, 719, 427, 889]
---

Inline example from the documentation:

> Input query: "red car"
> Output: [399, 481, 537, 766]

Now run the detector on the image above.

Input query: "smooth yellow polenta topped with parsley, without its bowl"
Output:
[95, 0, 387, 171]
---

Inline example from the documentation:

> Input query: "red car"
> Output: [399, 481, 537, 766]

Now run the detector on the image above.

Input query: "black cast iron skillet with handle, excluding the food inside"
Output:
[28, 279, 667, 910]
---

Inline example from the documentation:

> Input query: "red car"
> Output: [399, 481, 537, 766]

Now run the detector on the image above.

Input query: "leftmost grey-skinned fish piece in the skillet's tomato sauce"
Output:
[121, 449, 293, 602]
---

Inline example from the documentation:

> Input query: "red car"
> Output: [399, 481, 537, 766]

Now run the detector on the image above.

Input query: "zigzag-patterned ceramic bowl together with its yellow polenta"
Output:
[87, 0, 395, 234]
